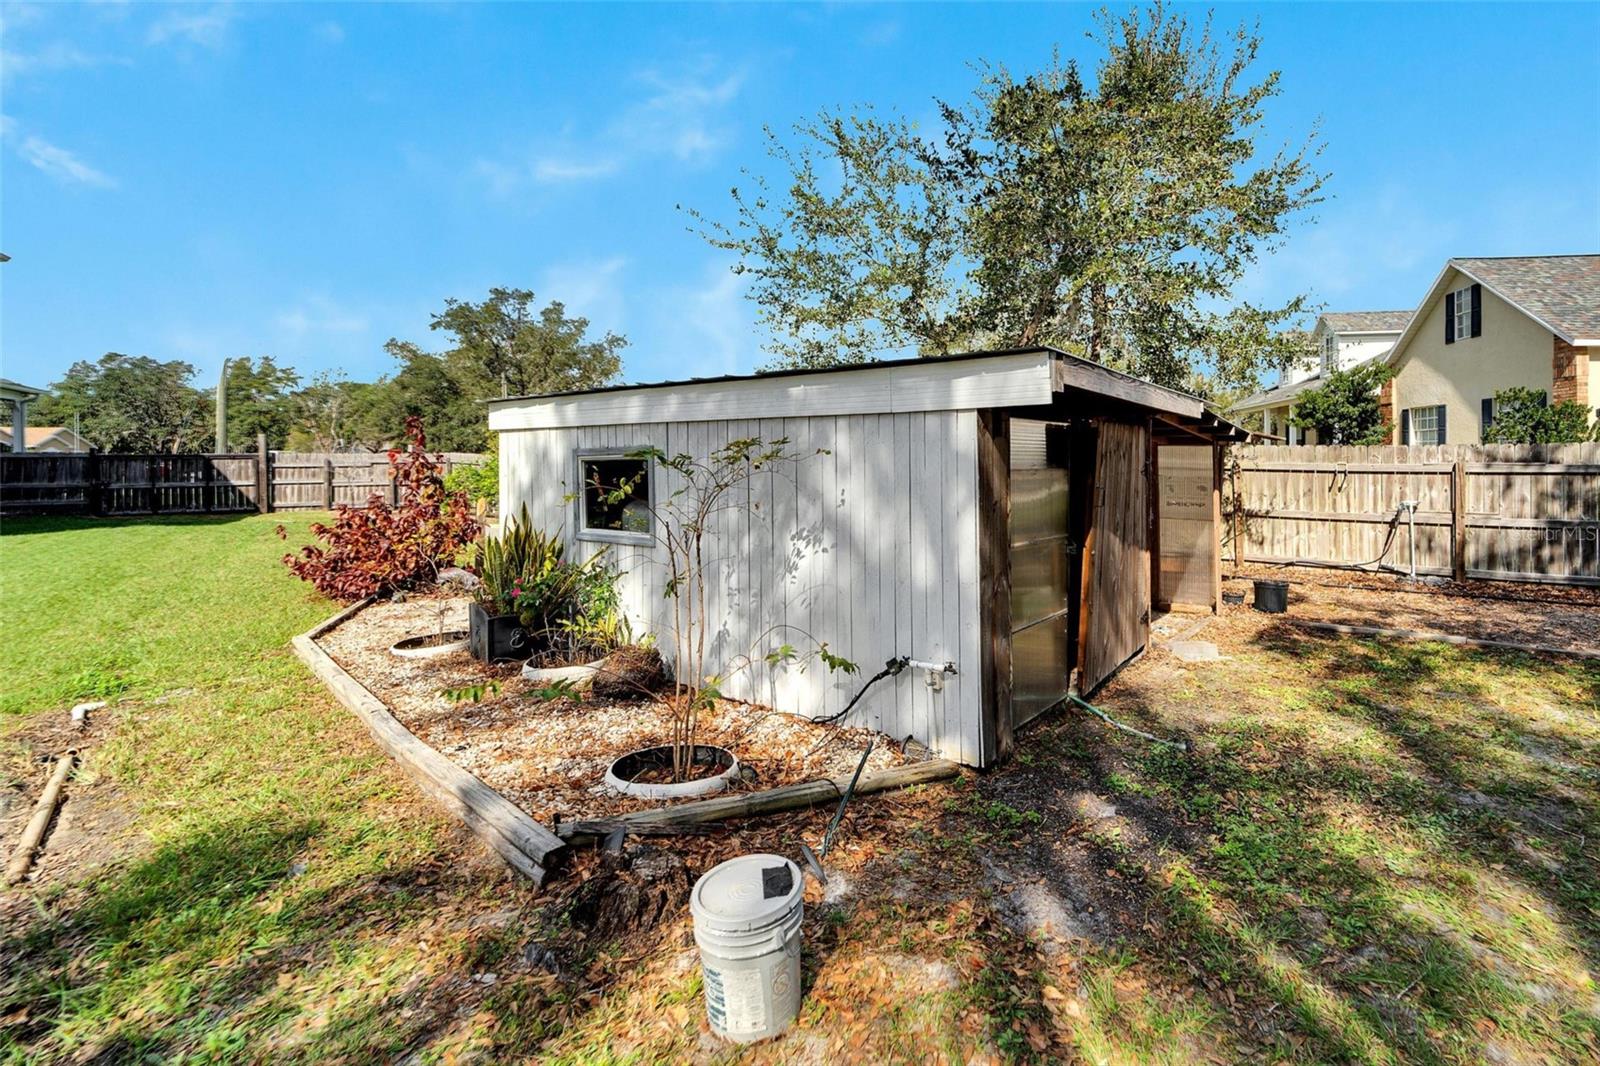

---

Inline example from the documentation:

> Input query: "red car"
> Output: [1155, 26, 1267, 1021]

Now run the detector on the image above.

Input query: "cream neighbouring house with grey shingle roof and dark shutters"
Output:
[1381, 254, 1600, 445]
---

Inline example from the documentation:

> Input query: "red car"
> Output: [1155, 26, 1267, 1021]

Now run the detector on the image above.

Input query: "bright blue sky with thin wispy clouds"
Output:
[0, 3, 1600, 392]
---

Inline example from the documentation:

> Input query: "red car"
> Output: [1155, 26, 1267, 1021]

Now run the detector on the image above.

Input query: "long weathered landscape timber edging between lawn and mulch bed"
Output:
[293, 599, 566, 885]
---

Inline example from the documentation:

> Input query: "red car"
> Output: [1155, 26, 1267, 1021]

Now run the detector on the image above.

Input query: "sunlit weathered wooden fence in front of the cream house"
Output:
[1224, 443, 1600, 586]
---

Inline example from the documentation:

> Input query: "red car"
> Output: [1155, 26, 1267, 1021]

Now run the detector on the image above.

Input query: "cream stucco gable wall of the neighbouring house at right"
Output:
[1394, 271, 1552, 443]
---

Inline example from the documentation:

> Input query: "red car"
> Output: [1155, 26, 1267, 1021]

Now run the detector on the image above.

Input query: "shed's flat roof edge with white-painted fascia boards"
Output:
[488, 347, 1241, 431]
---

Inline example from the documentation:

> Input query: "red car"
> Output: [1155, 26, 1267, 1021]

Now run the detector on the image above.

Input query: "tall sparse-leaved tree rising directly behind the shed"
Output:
[691, 5, 1323, 389]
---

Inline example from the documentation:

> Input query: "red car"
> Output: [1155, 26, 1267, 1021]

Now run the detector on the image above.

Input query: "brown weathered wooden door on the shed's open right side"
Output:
[1078, 423, 1150, 695]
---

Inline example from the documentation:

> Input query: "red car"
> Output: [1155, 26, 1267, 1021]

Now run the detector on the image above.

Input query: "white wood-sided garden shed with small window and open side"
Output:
[488, 347, 1243, 767]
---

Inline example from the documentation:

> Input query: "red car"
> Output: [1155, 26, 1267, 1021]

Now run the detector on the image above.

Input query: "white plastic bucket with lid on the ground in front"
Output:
[690, 855, 805, 1044]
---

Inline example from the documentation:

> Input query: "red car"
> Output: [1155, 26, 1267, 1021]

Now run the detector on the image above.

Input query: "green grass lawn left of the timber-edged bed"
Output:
[0, 515, 544, 1061]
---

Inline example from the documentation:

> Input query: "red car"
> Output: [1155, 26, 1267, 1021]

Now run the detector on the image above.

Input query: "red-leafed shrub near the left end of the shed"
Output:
[278, 415, 478, 600]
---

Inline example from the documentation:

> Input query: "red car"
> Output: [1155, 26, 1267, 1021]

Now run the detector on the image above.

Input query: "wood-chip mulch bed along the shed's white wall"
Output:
[318, 594, 907, 824]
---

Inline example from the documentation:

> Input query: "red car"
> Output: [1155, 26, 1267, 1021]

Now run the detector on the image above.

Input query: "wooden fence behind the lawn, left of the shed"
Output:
[0, 432, 485, 515]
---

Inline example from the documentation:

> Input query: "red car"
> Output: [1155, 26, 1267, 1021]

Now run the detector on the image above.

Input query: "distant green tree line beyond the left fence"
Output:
[20, 288, 627, 453]
